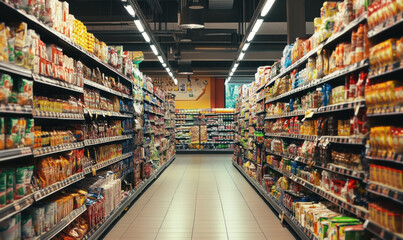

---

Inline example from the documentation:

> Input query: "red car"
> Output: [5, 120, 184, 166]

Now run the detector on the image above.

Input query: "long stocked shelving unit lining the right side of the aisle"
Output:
[233, 5, 403, 240]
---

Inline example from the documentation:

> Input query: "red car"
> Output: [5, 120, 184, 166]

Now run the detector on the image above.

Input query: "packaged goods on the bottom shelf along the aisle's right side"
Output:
[233, 161, 374, 240]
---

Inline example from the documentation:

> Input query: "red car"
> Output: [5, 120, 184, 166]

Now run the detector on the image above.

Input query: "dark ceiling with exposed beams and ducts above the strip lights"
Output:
[68, 0, 324, 79]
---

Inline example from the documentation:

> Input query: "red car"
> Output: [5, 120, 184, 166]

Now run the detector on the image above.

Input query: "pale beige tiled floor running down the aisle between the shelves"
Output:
[105, 154, 295, 240]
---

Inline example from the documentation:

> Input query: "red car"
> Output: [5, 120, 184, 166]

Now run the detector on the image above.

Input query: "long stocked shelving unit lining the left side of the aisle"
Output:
[0, 1, 175, 240]
